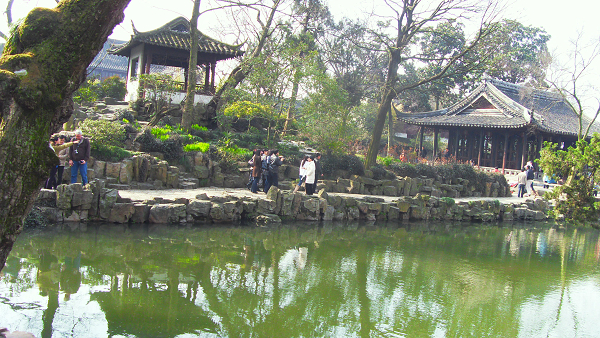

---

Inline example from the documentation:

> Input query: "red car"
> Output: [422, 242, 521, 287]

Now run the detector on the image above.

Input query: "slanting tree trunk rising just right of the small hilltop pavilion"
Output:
[206, 0, 281, 125]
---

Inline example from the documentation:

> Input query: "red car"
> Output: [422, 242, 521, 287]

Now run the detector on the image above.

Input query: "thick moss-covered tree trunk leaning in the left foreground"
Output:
[0, 0, 130, 269]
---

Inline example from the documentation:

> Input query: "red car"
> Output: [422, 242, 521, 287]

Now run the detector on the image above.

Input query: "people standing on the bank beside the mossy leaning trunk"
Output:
[44, 130, 90, 189]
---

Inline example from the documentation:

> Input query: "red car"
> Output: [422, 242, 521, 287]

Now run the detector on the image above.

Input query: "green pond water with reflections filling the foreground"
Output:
[0, 222, 600, 338]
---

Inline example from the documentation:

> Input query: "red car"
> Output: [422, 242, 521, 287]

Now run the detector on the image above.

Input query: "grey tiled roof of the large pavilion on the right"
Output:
[394, 79, 600, 136]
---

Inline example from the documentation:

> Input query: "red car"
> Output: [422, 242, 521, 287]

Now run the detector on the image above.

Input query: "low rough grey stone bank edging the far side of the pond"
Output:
[30, 180, 552, 225]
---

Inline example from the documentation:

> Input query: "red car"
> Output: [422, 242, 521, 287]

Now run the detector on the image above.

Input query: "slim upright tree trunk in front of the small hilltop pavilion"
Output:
[181, 0, 202, 129]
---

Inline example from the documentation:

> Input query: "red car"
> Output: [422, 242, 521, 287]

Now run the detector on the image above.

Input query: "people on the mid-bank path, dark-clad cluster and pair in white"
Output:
[248, 149, 323, 195]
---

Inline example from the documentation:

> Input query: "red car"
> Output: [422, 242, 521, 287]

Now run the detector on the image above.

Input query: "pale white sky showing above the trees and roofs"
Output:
[0, 0, 600, 112]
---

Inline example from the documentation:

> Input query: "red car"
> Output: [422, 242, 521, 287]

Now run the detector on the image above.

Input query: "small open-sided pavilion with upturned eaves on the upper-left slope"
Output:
[109, 17, 244, 103]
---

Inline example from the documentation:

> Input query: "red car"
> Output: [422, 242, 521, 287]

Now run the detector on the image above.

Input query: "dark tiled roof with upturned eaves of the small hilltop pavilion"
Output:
[110, 17, 244, 60]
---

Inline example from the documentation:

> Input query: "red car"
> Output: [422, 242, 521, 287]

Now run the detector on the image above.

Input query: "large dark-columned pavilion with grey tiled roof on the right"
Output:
[394, 79, 600, 171]
